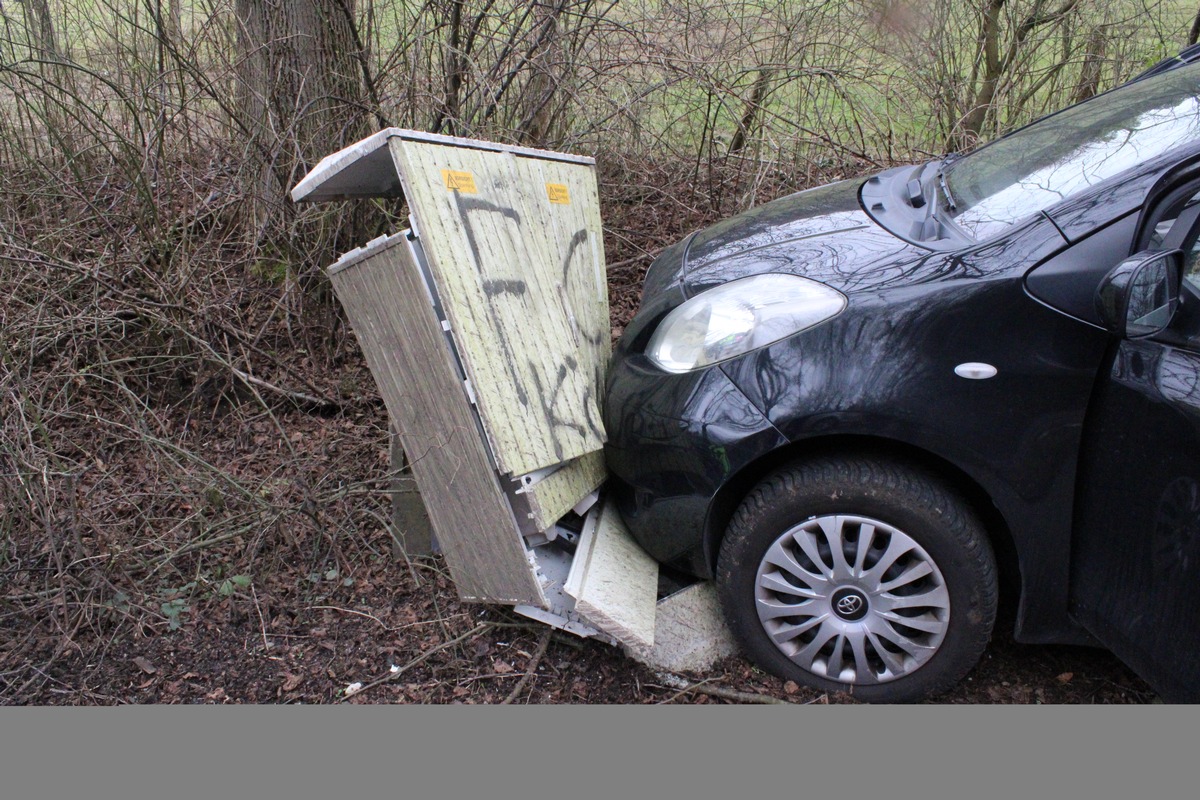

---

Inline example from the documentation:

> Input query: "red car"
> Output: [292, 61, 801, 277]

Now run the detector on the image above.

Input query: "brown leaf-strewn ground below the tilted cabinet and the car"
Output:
[5, 541, 1154, 705]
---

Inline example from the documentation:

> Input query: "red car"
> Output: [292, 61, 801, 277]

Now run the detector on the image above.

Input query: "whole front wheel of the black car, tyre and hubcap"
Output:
[716, 457, 998, 703]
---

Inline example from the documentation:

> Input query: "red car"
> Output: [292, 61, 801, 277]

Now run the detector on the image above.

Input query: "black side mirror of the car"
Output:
[1096, 249, 1183, 338]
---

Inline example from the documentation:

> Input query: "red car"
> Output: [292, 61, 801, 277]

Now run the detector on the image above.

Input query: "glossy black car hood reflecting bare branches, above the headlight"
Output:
[676, 181, 929, 295]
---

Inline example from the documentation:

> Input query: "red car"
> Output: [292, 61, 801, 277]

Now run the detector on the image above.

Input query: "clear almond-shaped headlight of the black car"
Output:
[646, 273, 846, 372]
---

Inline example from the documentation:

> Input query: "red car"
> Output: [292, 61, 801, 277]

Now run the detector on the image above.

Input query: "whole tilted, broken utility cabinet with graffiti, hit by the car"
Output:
[292, 128, 658, 654]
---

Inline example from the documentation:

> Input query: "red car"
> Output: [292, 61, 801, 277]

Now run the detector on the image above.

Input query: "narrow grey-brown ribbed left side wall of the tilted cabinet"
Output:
[329, 234, 545, 606]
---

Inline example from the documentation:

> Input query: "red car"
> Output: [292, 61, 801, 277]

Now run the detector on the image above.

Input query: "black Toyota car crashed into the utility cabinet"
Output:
[605, 64, 1200, 702]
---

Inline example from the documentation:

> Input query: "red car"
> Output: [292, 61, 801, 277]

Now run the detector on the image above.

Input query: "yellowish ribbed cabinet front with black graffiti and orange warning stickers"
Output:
[390, 137, 608, 475]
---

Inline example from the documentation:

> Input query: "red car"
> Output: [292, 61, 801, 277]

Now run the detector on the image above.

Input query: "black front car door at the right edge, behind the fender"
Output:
[1070, 184, 1200, 702]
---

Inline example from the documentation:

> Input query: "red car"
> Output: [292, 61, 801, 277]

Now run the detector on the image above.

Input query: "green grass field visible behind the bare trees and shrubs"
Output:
[9, 0, 1194, 169]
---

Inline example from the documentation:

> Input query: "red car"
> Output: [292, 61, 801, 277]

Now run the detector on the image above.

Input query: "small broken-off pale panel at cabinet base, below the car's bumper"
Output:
[563, 503, 659, 654]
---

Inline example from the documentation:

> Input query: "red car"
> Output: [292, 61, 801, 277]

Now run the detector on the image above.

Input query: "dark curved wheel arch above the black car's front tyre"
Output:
[703, 434, 1024, 608]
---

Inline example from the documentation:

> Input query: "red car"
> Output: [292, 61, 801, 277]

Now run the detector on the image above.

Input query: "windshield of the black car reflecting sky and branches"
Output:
[942, 64, 1200, 240]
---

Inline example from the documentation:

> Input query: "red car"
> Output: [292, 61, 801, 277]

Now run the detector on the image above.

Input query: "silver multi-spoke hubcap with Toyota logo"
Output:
[755, 515, 950, 685]
